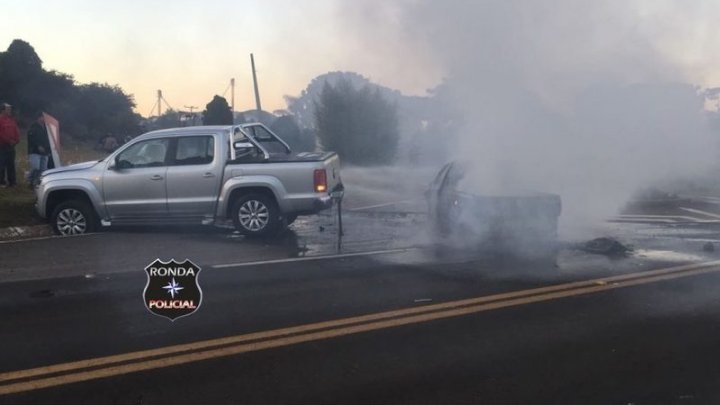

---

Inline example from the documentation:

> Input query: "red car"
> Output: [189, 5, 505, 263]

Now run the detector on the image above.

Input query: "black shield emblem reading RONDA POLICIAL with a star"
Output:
[143, 259, 202, 321]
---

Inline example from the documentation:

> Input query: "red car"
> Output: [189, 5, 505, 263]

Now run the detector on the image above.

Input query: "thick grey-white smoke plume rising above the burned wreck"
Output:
[340, 0, 718, 235]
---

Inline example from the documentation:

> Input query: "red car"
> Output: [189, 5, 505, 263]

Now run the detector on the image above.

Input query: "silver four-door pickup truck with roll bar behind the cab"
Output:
[36, 124, 343, 235]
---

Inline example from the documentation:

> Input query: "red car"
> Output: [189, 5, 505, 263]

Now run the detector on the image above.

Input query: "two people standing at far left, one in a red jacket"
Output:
[0, 103, 50, 187]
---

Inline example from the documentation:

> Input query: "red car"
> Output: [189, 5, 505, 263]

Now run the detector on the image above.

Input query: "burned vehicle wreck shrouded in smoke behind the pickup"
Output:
[425, 161, 562, 261]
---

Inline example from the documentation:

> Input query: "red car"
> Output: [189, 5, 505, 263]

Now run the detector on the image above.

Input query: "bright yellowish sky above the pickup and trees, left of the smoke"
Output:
[0, 0, 439, 116]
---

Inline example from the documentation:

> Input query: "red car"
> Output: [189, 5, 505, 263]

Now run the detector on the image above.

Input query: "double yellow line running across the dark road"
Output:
[0, 261, 720, 395]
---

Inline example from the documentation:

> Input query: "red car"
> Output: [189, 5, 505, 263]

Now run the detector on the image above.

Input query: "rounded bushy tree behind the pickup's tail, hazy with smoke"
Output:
[315, 80, 400, 165]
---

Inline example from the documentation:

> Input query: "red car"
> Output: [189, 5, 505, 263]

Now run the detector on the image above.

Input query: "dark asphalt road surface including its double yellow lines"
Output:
[0, 187, 720, 404]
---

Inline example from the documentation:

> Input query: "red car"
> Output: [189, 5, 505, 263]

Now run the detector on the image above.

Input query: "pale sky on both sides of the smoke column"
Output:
[0, 0, 720, 116]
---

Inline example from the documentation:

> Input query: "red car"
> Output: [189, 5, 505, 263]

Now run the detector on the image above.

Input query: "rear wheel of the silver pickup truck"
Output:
[231, 194, 281, 236]
